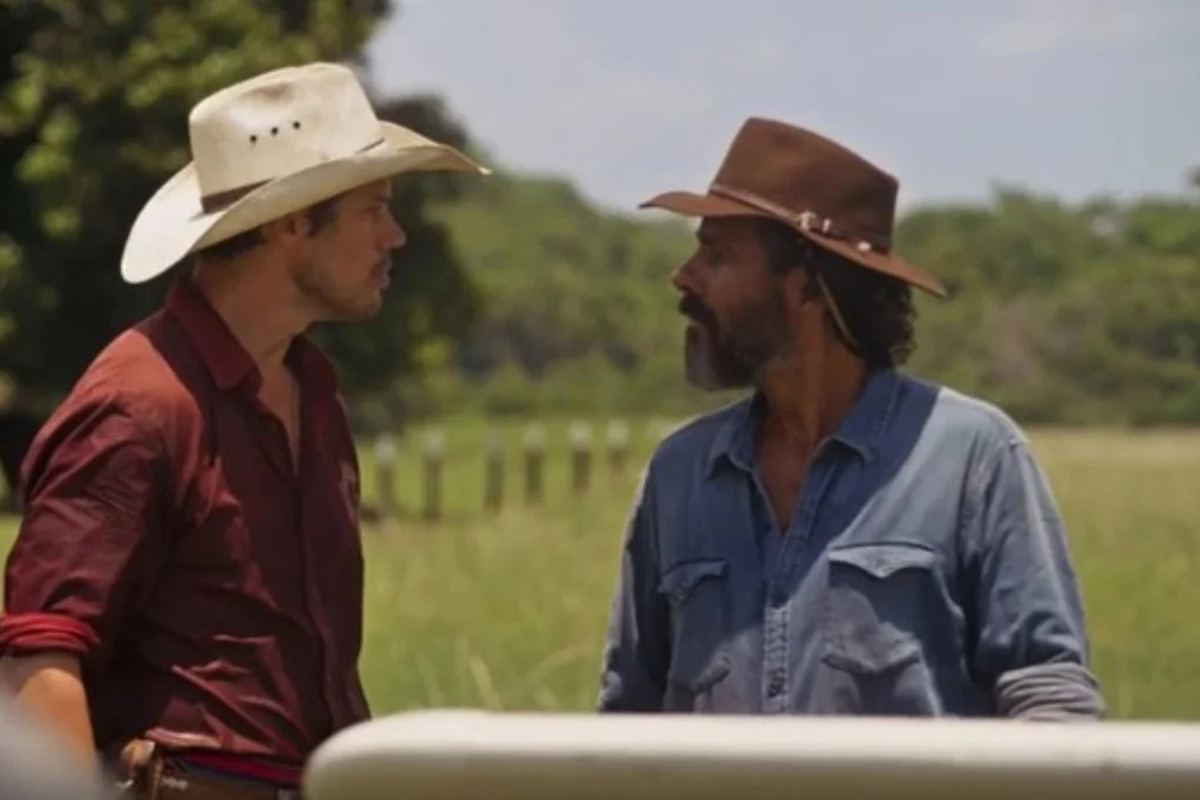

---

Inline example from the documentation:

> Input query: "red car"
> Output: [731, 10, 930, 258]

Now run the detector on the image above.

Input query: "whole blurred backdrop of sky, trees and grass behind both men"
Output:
[0, 0, 1200, 718]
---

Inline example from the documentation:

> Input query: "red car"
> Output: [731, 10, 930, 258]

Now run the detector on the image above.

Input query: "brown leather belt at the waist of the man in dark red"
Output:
[118, 739, 301, 800]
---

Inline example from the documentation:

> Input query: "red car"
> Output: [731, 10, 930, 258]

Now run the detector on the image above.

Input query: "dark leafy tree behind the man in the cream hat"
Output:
[0, 0, 476, 408]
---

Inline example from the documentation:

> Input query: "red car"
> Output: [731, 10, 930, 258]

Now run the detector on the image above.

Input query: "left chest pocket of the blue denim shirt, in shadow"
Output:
[659, 559, 730, 710]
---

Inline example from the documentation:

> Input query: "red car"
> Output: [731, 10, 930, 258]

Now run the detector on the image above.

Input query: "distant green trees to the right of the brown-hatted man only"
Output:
[898, 185, 1200, 425]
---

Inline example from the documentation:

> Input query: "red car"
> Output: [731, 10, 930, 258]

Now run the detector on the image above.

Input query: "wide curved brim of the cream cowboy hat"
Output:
[114, 122, 491, 283]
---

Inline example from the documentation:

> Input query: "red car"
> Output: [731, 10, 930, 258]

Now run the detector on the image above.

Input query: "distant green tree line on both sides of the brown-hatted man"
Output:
[413, 169, 1200, 425]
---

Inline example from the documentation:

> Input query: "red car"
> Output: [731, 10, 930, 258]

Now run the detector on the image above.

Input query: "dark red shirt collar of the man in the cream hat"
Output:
[167, 276, 337, 392]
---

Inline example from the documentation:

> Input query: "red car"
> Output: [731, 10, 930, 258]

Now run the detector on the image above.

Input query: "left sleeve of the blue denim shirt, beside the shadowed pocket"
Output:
[598, 470, 670, 711]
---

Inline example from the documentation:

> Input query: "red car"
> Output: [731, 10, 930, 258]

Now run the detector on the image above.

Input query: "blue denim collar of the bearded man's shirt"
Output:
[708, 368, 900, 475]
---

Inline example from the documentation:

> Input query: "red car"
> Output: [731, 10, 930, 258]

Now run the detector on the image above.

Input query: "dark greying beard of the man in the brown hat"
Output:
[679, 293, 787, 391]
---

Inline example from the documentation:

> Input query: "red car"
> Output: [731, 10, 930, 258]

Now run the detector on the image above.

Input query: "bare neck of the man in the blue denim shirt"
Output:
[758, 344, 866, 452]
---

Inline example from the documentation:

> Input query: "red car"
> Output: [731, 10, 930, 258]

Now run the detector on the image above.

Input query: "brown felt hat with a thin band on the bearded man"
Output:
[638, 118, 946, 297]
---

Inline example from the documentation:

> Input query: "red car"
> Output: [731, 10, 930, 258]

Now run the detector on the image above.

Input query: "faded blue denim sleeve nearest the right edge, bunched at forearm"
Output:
[964, 437, 1104, 720]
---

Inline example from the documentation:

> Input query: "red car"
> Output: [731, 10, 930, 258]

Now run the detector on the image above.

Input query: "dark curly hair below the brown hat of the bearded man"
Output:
[758, 219, 917, 369]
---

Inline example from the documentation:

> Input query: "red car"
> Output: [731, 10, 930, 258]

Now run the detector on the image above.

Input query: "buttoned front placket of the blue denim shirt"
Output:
[754, 449, 833, 714]
